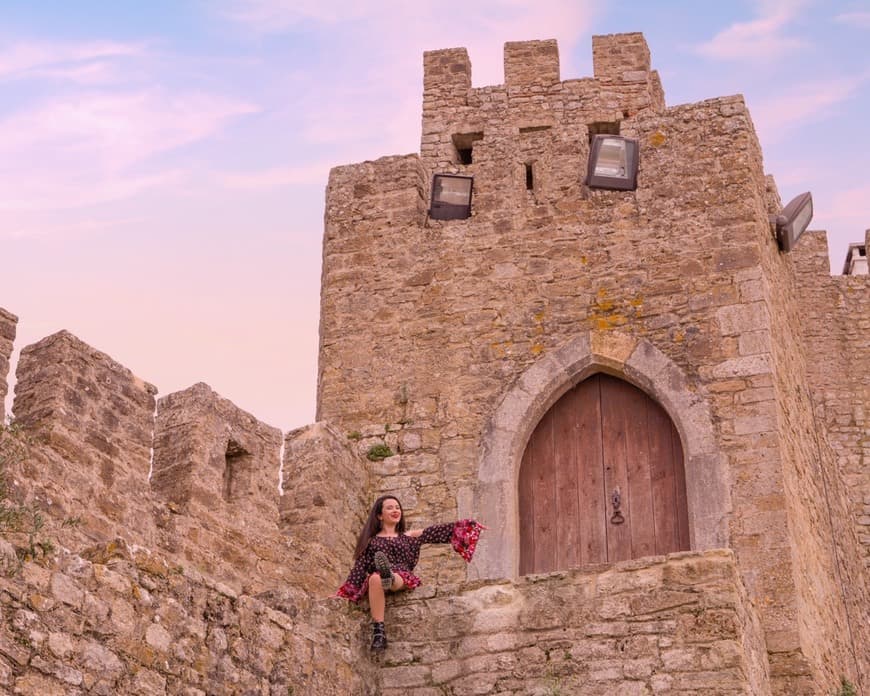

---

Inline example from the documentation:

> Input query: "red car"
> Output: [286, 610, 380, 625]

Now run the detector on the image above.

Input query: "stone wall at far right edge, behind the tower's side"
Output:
[790, 233, 870, 680]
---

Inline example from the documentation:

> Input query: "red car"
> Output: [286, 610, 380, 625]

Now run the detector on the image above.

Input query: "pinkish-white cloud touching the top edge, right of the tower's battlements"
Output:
[695, 0, 808, 61]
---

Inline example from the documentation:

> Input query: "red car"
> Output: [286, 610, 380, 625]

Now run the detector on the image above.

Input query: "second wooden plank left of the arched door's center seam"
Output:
[552, 388, 582, 570]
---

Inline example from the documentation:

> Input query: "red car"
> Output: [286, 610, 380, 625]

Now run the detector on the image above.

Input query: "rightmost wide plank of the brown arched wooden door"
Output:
[648, 403, 679, 554]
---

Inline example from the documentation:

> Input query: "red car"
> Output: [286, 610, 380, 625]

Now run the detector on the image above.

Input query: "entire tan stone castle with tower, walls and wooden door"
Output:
[0, 33, 870, 696]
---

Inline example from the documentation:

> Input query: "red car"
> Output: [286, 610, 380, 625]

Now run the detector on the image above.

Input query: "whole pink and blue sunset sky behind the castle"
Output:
[0, 0, 870, 428]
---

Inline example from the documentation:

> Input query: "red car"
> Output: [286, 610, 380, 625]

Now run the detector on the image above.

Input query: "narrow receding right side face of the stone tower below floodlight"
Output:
[744, 215, 870, 691]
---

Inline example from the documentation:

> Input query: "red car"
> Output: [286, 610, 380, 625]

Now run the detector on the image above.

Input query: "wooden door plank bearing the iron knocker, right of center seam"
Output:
[601, 375, 631, 562]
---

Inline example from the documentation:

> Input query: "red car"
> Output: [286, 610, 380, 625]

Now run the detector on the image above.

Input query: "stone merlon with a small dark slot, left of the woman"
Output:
[151, 383, 289, 589]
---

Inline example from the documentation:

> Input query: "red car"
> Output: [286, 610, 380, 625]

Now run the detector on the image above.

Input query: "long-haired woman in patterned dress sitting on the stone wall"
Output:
[337, 495, 486, 651]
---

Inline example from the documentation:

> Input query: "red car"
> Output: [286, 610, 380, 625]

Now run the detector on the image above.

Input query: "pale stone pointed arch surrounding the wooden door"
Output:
[459, 331, 731, 578]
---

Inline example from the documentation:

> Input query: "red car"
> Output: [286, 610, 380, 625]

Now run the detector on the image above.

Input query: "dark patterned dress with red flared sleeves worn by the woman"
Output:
[337, 520, 482, 602]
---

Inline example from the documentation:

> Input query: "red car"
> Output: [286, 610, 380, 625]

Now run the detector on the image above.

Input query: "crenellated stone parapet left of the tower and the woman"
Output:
[2, 324, 365, 591]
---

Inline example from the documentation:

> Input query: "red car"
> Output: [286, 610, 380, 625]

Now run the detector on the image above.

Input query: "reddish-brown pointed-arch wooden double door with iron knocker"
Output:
[519, 374, 689, 575]
